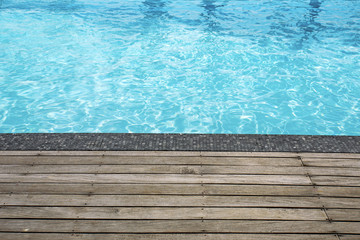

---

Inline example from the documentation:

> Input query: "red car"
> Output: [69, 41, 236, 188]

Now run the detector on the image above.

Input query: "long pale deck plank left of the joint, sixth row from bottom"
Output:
[0, 174, 311, 185]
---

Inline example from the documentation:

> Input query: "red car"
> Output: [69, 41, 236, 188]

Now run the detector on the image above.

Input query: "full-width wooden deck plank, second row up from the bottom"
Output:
[0, 219, 360, 234]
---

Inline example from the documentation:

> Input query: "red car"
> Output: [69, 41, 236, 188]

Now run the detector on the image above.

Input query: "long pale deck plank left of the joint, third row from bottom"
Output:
[0, 206, 326, 221]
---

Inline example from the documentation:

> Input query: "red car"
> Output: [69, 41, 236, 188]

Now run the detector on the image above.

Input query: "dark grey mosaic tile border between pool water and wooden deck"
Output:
[0, 133, 360, 153]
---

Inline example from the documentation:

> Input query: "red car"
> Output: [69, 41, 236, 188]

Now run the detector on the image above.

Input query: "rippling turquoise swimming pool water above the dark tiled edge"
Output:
[0, 0, 360, 135]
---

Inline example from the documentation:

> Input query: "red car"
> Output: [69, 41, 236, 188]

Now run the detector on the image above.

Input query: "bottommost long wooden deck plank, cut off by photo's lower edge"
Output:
[0, 232, 340, 240]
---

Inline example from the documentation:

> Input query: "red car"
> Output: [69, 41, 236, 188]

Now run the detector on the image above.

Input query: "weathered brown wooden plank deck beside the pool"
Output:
[0, 151, 360, 240]
